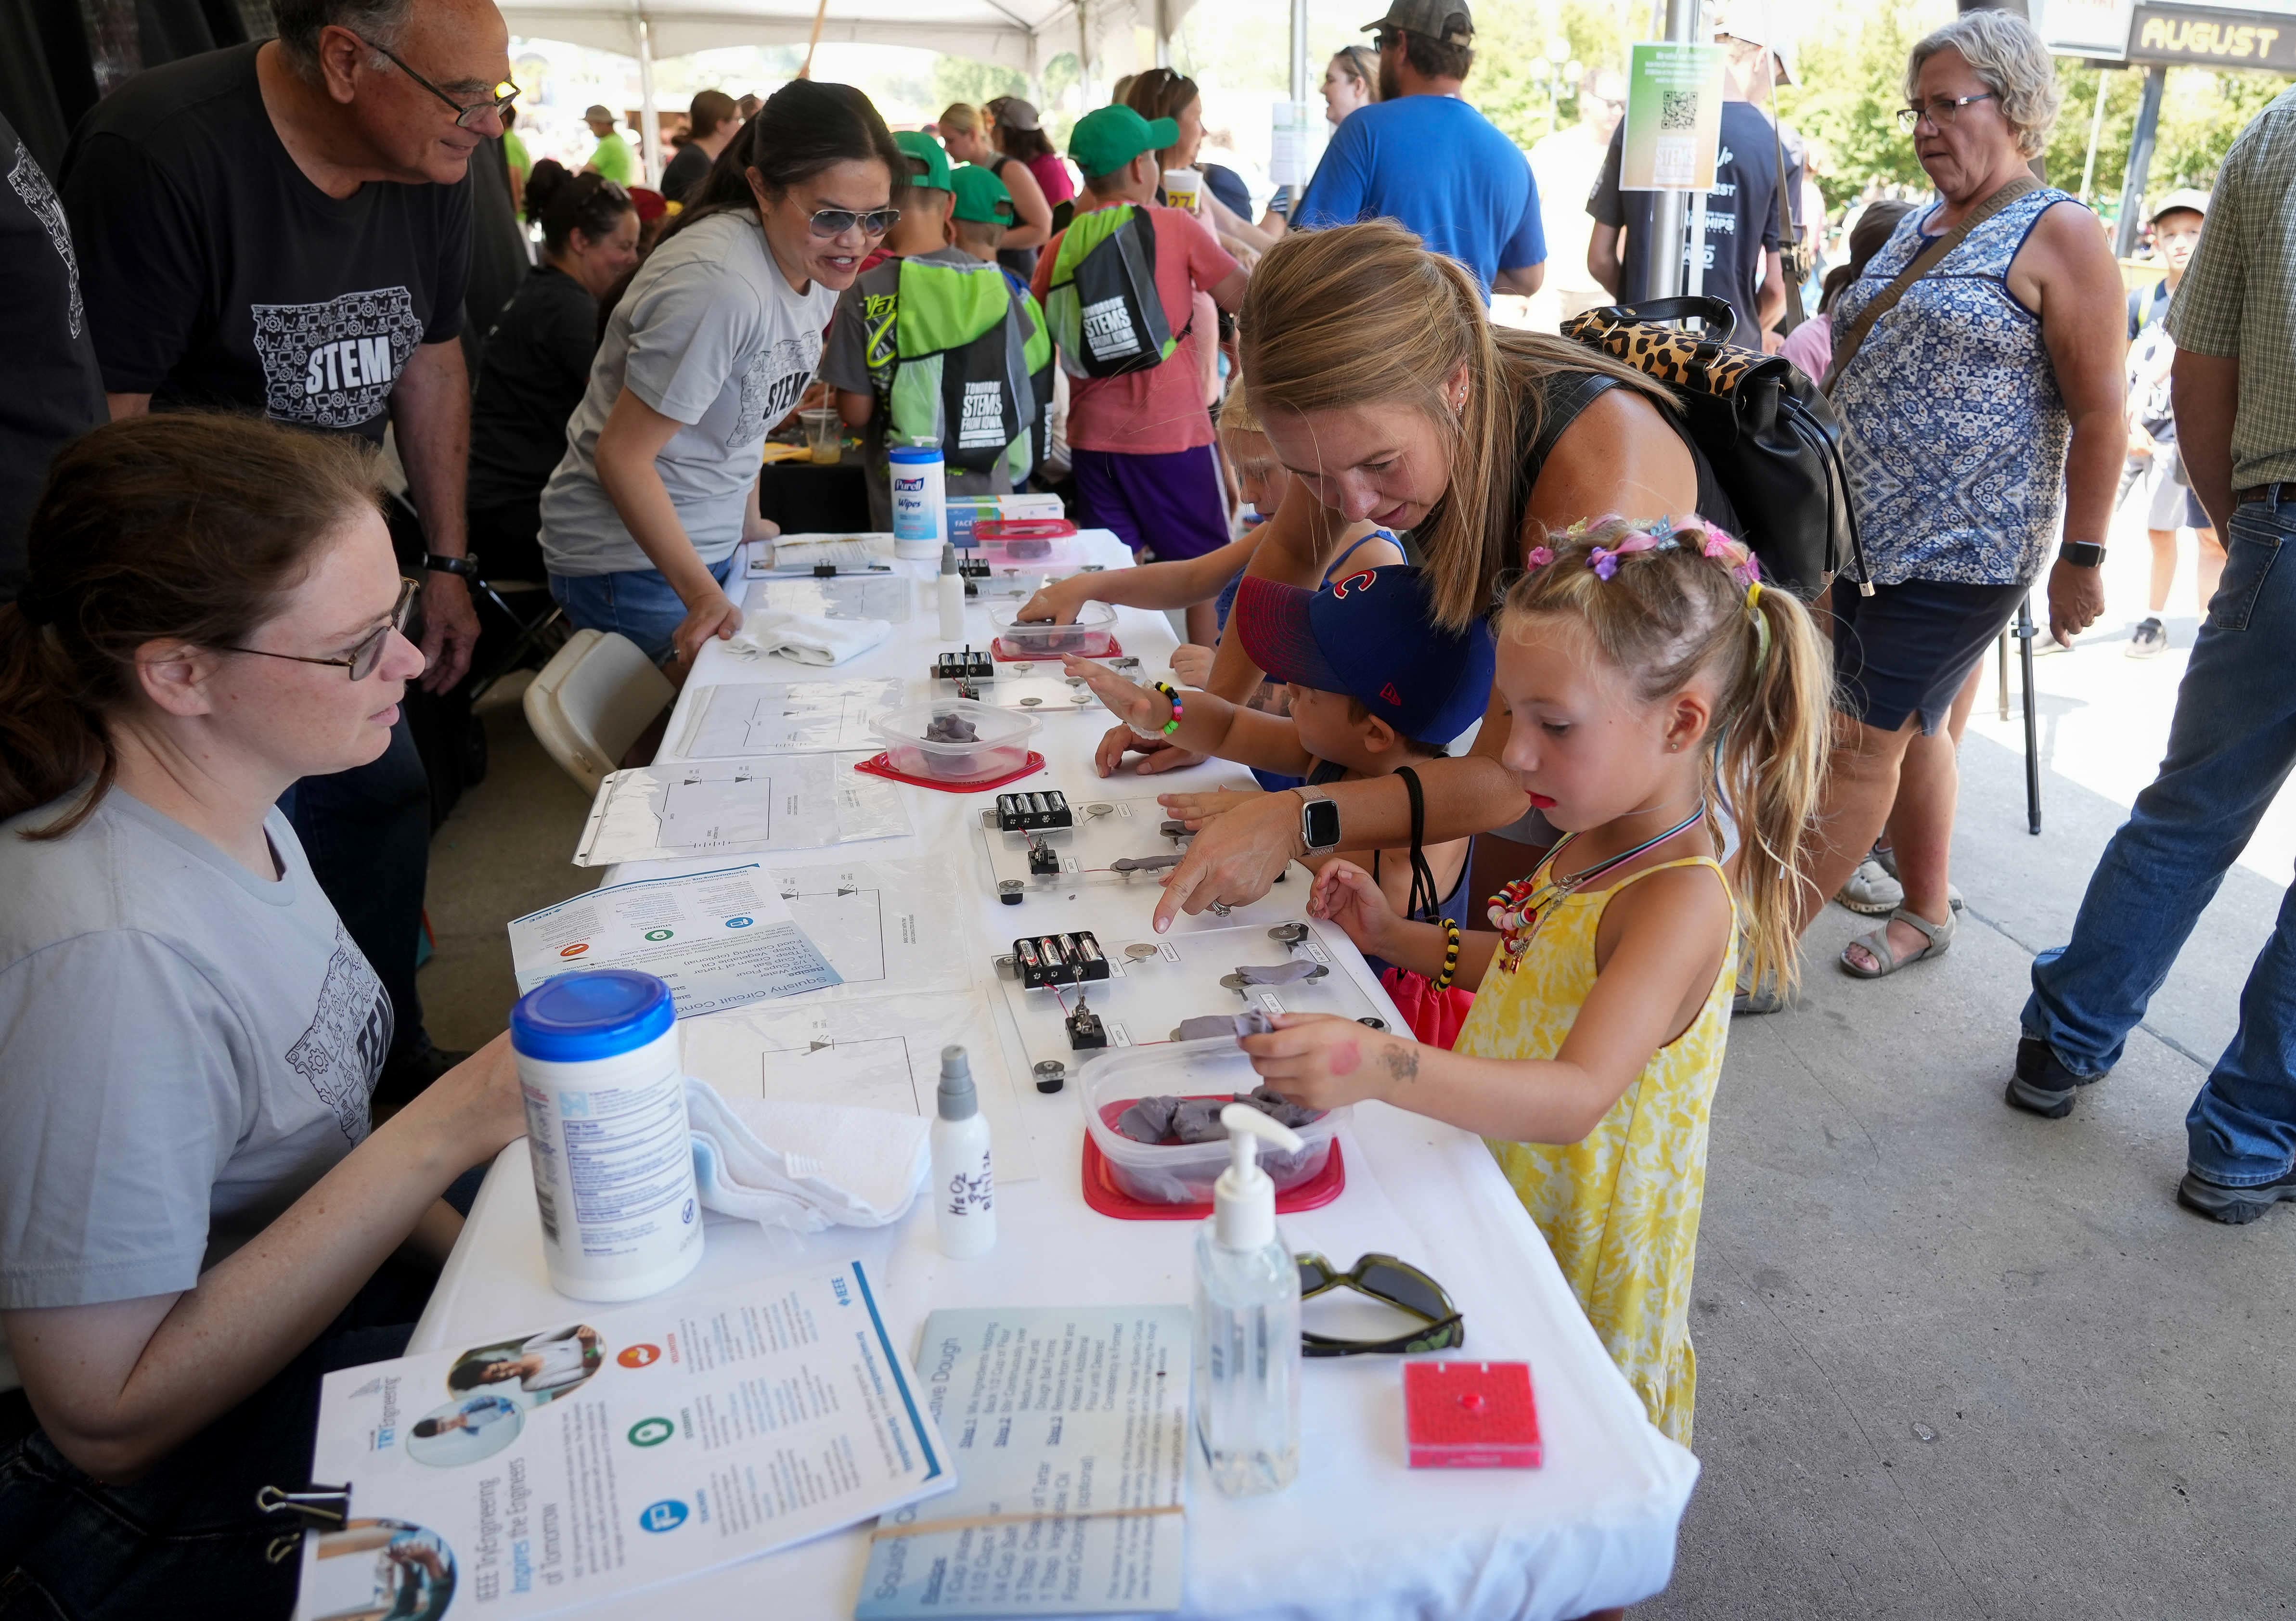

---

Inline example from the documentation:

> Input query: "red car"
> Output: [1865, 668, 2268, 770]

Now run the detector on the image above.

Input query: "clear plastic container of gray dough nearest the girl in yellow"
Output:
[1074, 1036, 1348, 1206]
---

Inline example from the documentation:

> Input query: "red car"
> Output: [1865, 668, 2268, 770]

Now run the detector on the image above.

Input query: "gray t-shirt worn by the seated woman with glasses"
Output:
[0, 787, 390, 1389]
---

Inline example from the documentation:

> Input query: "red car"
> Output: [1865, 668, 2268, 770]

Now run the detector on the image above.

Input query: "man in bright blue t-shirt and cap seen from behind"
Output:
[1293, 0, 1548, 296]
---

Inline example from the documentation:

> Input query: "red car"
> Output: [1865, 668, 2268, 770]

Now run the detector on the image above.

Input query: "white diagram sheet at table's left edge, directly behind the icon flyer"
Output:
[574, 753, 909, 868]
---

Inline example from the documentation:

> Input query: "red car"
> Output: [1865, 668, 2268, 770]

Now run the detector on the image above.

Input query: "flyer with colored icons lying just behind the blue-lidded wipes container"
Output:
[510, 863, 843, 1019]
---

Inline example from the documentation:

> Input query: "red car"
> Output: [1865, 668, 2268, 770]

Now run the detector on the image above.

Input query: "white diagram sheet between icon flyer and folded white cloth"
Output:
[677, 990, 1035, 1183]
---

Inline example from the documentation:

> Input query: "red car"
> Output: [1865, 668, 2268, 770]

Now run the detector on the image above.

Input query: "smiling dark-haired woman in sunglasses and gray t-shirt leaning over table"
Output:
[542, 80, 900, 668]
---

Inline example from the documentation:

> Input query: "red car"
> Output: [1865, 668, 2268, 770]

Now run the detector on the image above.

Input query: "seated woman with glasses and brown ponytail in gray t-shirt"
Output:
[0, 413, 526, 1616]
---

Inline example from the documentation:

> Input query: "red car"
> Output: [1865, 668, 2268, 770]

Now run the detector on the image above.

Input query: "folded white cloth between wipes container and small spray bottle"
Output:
[686, 1075, 932, 1233]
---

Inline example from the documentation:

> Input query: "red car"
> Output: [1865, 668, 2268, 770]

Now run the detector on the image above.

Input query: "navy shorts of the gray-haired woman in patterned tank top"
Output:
[1832, 579, 2032, 737]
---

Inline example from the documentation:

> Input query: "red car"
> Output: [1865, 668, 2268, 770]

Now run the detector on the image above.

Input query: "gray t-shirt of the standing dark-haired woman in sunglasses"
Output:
[542, 214, 838, 574]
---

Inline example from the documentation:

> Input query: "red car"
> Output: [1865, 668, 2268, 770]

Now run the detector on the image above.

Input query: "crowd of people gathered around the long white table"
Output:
[0, 0, 2296, 1616]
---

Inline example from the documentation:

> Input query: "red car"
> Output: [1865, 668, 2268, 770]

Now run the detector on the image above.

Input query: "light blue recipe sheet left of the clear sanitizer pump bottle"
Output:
[854, 1306, 1194, 1621]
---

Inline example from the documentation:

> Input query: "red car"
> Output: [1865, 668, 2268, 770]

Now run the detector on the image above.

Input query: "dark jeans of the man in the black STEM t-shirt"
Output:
[280, 714, 429, 1058]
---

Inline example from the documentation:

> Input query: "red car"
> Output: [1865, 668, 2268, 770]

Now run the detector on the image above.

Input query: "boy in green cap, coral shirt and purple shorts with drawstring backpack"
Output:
[1035, 105, 1244, 560]
